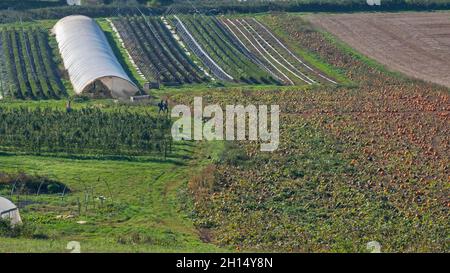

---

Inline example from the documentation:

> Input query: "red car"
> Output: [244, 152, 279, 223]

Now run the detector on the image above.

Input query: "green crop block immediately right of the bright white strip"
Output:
[179, 15, 277, 84]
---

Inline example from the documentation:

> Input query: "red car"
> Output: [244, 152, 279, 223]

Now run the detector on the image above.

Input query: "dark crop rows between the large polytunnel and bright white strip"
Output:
[115, 17, 206, 85]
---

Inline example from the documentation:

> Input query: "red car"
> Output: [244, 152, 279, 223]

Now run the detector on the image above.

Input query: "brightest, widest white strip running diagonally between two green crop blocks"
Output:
[174, 15, 233, 81]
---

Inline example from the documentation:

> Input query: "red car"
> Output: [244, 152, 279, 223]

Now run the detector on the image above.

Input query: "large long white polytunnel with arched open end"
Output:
[53, 15, 139, 99]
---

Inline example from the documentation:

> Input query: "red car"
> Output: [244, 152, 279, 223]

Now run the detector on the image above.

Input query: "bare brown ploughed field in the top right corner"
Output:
[309, 12, 450, 87]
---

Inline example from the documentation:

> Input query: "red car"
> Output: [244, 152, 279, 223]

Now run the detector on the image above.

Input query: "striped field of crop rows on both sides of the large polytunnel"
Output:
[0, 15, 334, 100]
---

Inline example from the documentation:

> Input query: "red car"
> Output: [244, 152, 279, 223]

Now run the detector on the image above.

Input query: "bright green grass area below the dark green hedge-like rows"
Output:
[0, 136, 226, 252]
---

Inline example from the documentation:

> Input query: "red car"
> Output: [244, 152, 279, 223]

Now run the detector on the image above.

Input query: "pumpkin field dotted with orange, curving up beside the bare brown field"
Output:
[171, 12, 450, 252]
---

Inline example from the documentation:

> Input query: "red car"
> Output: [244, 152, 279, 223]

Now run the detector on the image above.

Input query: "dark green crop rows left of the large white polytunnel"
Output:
[0, 27, 66, 99]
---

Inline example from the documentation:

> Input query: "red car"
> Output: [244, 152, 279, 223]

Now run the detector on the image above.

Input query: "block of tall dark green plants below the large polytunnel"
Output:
[0, 108, 172, 156]
